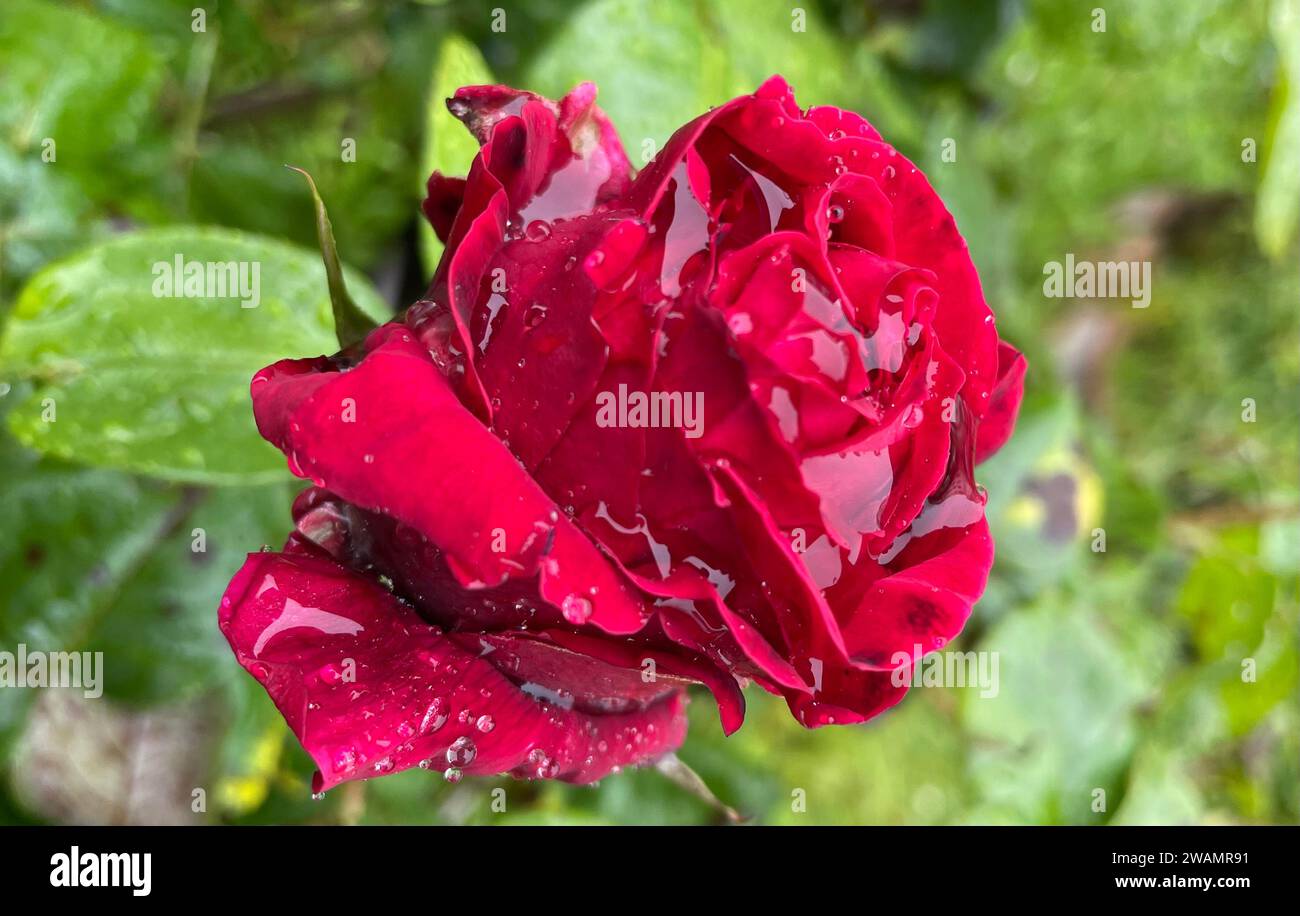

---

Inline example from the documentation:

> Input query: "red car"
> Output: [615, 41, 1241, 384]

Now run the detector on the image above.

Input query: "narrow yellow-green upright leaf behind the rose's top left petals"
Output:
[419, 34, 495, 277]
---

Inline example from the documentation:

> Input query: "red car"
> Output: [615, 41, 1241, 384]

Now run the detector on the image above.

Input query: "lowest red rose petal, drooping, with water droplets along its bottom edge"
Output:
[220, 545, 686, 791]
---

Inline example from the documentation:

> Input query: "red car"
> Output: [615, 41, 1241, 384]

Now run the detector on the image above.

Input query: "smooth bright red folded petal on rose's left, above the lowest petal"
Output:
[252, 325, 646, 633]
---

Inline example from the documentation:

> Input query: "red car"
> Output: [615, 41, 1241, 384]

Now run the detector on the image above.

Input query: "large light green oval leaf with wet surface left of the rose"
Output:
[0, 227, 387, 483]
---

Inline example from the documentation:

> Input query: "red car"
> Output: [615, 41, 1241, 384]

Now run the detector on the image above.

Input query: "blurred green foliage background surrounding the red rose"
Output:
[0, 0, 1300, 824]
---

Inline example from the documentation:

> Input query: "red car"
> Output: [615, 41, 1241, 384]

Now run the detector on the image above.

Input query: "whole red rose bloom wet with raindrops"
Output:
[220, 77, 1024, 791]
